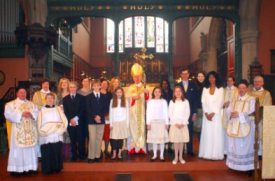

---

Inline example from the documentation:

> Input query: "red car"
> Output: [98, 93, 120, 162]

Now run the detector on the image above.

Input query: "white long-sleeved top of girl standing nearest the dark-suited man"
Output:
[169, 99, 190, 125]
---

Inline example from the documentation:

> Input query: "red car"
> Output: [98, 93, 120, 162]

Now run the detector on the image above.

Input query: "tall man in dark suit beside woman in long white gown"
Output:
[177, 69, 200, 156]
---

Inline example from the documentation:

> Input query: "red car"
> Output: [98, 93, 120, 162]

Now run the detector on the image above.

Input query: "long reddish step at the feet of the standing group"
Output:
[63, 159, 228, 172]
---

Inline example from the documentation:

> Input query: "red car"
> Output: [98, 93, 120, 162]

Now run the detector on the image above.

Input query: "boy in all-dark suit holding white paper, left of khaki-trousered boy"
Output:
[63, 82, 87, 161]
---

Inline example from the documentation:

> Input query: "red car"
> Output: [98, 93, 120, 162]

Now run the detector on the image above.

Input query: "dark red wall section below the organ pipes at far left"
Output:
[0, 56, 29, 98]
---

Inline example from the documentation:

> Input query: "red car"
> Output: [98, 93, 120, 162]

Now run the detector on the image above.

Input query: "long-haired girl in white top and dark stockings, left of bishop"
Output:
[109, 87, 129, 159]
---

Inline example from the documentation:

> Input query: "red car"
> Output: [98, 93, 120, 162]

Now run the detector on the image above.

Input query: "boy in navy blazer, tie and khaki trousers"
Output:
[86, 80, 109, 163]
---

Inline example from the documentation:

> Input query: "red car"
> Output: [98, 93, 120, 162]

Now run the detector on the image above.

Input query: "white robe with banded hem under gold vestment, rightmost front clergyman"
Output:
[226, 95, 255, 171]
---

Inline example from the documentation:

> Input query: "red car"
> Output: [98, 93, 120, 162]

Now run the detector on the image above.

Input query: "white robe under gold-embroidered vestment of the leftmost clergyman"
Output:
[5, 98, 38, 172]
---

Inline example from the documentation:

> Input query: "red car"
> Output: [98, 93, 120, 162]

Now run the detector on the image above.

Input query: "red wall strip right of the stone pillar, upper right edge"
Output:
[258, 0, 275, 74]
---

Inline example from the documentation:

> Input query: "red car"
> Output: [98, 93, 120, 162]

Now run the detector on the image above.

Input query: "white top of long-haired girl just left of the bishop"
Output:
[109, 99, 129, 126]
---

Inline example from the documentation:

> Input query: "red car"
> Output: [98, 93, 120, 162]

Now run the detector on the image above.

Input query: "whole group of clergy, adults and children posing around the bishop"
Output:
[5, 64, 271, 174]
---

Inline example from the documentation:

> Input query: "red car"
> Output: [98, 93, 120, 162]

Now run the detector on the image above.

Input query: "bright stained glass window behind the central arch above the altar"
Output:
[106, 16, 169, 53]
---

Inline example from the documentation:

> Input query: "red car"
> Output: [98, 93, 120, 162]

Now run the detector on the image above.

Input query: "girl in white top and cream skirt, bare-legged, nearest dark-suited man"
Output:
[169, 86, 190, 164]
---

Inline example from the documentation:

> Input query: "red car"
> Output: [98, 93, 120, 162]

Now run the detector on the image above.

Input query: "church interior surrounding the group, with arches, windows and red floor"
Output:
[0, 0, 275, 181]
